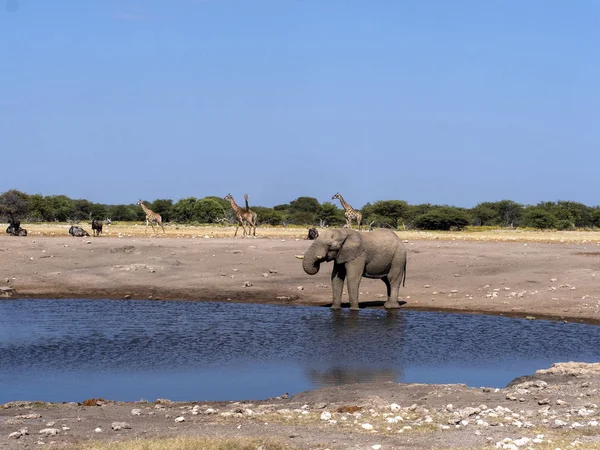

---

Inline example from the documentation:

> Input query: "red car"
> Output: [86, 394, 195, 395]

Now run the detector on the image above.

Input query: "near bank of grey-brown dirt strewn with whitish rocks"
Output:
[0, 362, 600, 449]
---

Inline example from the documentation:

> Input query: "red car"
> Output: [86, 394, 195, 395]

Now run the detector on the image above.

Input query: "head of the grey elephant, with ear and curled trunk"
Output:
[302, 228, 365, 275]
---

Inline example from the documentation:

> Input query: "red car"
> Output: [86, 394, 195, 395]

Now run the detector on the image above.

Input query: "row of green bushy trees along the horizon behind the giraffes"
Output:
[0, 189, 600, 230]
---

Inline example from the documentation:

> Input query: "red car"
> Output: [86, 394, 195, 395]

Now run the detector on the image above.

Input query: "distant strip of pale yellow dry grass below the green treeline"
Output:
[3, 222, 600, 244]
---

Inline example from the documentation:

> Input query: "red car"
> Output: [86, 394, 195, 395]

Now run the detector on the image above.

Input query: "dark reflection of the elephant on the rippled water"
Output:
[306, 310, 405, 387]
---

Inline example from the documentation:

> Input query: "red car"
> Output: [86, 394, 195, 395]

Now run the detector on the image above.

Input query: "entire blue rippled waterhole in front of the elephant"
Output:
[0, 300, 600, 403]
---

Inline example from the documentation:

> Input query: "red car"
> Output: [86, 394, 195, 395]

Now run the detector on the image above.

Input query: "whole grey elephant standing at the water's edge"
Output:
[302, 228, 406, 310]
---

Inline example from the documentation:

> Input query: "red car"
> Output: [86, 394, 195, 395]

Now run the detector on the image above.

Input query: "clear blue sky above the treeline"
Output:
[0, 0, 600, 207]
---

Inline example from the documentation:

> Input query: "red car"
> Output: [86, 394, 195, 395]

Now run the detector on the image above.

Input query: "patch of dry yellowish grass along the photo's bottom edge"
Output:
[72, 437, 295, 450]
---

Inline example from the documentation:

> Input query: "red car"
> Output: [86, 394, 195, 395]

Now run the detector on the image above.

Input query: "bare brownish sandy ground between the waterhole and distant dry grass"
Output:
[0, 227, 600, 323]
